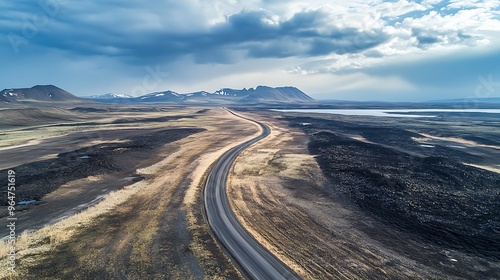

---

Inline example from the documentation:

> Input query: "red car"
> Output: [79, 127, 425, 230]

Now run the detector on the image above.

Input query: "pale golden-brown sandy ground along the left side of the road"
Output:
[0, 106, 258, 279]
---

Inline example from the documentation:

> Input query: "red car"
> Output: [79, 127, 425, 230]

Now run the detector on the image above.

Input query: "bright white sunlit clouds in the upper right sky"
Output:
[291, 1, 500, 73]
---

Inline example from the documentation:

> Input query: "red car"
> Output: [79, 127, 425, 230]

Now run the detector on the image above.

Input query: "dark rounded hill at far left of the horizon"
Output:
[0, 85, 85, 103]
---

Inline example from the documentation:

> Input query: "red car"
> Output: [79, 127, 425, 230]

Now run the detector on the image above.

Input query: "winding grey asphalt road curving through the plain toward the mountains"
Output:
[204, 110, 300, 280]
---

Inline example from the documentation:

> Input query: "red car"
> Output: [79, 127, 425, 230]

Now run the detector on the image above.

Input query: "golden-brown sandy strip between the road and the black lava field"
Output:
[228, 110, 498, 279]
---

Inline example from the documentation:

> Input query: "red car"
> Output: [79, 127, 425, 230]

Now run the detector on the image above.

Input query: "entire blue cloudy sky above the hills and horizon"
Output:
[0, 0, 500, 101]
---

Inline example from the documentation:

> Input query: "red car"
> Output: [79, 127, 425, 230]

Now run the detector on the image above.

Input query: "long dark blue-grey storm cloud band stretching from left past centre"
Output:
[3, 6, 388, 63]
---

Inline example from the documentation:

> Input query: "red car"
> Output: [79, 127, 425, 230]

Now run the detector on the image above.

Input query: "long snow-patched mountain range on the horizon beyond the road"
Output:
[84, 86, 314, 104]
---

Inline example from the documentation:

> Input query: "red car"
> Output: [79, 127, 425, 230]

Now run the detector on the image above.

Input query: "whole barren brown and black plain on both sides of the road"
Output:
[0, 105, 500, 279]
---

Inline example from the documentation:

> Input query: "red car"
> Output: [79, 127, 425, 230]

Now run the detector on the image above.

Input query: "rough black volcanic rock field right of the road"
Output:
[292, 118, 500, 260]
